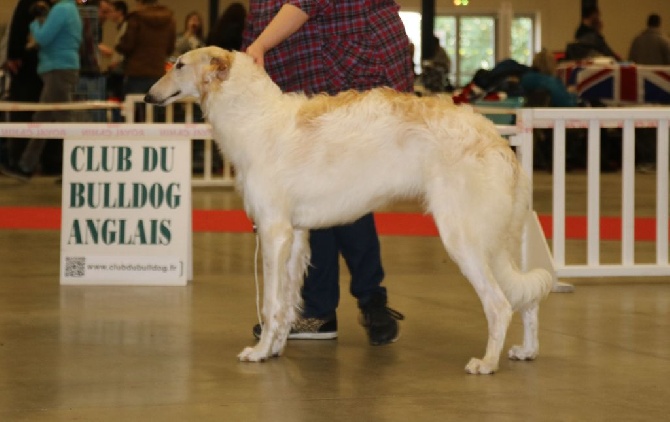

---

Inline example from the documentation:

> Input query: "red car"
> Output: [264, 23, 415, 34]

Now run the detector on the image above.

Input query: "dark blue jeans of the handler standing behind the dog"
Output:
[302, 214, 386, 318]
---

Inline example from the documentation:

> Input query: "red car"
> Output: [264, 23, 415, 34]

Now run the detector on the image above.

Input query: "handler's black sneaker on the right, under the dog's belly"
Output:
[360, 295, 405, 346]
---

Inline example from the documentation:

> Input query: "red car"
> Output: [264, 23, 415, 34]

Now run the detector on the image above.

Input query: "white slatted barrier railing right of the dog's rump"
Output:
[517, 107, 670, 277]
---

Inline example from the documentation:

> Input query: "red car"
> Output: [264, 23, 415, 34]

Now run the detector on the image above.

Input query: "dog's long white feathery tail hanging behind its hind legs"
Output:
[491, 168, 553, 310]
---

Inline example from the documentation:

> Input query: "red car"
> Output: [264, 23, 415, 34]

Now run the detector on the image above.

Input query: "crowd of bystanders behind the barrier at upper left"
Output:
[0, 0, 246, 181]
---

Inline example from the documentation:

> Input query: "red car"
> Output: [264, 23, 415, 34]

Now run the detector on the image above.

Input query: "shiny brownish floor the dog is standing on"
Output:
[0, 173, 670, 422]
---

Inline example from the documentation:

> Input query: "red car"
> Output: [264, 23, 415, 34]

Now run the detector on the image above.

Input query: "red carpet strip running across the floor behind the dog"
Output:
[0, 207, 656, 241]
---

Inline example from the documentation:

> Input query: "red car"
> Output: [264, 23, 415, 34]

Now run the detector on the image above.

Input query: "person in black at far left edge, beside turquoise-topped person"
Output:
[0, 0, 42, 172]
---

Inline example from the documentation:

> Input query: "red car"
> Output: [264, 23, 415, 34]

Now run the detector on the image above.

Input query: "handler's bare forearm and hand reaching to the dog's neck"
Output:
[246, 4, 309, 66]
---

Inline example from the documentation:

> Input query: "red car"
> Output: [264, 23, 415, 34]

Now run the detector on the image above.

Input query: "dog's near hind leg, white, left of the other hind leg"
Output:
[433, 208, 512, 374]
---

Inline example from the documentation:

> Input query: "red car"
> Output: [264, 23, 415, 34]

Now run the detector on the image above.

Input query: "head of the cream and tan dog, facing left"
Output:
[144, 47, 235, 106]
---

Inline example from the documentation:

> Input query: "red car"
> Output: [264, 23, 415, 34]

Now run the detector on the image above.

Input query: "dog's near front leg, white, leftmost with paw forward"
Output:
[238, 221, 293, 362]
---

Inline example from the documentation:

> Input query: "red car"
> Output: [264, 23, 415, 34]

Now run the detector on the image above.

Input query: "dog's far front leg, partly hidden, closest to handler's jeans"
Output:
[272, 229, 310, 356]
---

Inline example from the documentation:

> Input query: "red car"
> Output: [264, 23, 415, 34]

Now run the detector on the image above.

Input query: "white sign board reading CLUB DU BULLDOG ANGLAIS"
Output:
[60, 138, 192, 286]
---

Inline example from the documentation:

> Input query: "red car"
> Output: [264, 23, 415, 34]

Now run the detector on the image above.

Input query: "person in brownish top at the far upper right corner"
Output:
[628, 13, 670, 65]
